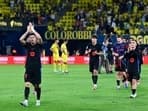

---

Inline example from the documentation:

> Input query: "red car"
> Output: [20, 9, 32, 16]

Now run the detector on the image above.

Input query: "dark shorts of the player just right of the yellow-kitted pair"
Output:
[89, 59, 99, 73]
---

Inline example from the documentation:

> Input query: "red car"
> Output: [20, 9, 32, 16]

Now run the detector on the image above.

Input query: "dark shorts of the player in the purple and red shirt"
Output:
[115, 58, 126, 72]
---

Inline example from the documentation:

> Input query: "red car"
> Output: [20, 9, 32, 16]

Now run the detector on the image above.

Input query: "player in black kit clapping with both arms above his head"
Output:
[19, 23, 43, 107]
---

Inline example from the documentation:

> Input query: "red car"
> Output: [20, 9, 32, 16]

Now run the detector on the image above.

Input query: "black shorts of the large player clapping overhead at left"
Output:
[24, 68, 41, 85]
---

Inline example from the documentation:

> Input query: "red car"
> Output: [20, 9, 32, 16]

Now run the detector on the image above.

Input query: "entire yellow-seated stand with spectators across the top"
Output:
[0, 0, 148, 34]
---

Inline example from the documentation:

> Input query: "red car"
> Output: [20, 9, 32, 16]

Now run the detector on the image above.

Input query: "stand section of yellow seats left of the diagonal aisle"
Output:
[0, 0, 74, 25]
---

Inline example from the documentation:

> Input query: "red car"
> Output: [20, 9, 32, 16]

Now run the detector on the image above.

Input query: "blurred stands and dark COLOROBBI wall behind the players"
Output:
[0, 0, 148, 56]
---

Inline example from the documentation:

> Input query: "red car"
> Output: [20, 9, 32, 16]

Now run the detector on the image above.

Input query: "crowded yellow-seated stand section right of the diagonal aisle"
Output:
[53, 0, 148, 34]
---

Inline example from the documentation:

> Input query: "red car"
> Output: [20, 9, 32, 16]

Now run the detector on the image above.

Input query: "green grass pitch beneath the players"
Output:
[0, 65, 148, 111]
